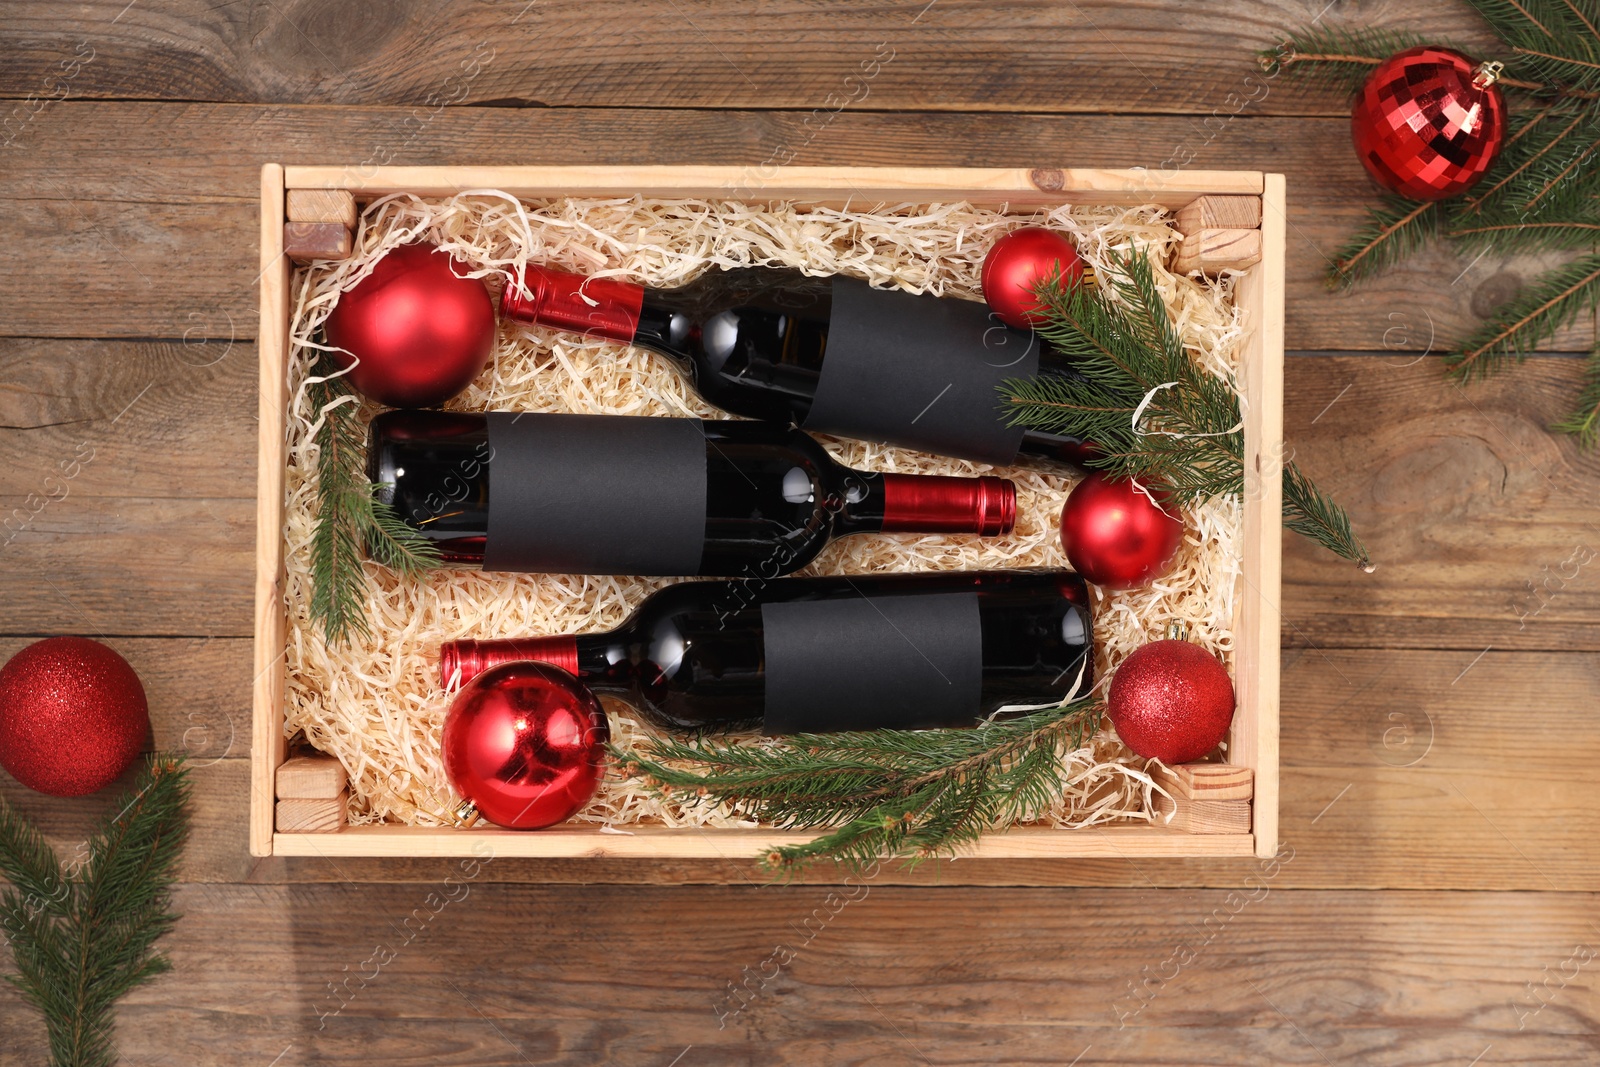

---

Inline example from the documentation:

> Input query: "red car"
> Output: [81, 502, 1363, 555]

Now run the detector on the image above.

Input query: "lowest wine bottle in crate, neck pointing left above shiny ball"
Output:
[440, 569, 1093, 734]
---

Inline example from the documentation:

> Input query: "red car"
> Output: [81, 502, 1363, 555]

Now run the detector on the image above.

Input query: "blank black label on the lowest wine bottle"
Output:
[762, 592, 984, 734]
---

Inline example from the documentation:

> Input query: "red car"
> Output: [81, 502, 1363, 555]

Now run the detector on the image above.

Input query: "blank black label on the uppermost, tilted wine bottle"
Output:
[805, 277, 1038, 464]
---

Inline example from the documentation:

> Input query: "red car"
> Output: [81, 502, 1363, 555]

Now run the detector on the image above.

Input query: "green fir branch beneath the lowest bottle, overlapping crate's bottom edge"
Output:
[613, 699, 1104, 873]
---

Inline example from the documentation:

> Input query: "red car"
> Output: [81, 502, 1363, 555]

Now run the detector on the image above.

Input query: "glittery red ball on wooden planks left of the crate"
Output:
[0, 637, 150, 797]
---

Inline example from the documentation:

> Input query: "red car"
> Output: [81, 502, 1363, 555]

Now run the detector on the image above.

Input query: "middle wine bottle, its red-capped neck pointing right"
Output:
[366, 411, 1016, 577]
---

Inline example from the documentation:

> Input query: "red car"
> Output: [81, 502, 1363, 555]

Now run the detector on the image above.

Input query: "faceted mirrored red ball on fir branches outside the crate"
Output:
[1350, 46, 1506, 200]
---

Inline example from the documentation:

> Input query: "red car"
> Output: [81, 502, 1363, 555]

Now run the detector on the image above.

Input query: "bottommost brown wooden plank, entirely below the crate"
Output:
[0, 883, 1600, 1067]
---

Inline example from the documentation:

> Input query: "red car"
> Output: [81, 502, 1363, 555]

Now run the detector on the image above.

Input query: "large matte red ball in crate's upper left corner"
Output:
[326, 245, 494, 408]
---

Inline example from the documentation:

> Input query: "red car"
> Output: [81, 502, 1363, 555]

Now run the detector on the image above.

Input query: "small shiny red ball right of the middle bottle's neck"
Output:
[1061, 474, 1184, 589]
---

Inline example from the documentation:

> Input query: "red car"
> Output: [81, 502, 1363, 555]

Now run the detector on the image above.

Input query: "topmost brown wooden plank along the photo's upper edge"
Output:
[0, 0, 1490, 111]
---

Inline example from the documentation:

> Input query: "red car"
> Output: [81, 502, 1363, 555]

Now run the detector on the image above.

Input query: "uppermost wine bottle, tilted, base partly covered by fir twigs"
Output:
[501, 264, 1088, 467]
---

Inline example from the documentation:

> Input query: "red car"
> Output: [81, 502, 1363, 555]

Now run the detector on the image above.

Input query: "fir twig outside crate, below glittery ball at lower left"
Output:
[0, 757, 189, 1067]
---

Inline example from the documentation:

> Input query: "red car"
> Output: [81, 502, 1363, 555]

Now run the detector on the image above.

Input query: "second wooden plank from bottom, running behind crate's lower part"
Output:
[0, 638, 1600, 891]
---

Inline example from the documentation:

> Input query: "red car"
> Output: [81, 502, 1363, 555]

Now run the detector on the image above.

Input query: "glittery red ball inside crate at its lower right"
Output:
[1106, 640, 1234, 766]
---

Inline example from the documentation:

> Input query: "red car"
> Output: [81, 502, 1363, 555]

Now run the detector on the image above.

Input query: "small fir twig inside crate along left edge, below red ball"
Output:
[309, 355, 440, 645]
